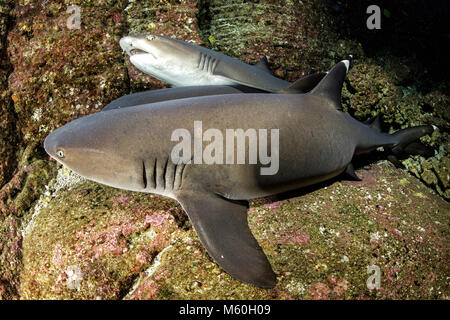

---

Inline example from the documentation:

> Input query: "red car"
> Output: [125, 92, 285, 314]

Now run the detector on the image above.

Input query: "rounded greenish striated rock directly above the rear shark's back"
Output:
[199, 0, 342, 81]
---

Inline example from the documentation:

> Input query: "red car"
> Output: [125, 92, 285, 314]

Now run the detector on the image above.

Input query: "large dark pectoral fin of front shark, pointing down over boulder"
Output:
[176, 192, 276, 288]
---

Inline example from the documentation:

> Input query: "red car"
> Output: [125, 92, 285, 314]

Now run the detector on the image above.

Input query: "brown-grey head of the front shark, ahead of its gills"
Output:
[44, 112, 147, 191]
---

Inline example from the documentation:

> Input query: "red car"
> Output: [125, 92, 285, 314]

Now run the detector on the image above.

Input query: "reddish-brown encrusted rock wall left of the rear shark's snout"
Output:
[8, 1, 128, 144]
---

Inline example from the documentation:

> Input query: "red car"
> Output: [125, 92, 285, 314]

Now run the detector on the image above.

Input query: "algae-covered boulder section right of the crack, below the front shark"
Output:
[121, 163, 450, 299]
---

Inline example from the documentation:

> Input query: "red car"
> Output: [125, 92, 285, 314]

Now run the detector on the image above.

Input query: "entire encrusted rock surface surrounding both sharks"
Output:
[0, 0, 450, 299]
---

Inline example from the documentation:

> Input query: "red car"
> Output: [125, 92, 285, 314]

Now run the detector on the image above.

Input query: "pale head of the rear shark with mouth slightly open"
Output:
[120, 34, 236, 86]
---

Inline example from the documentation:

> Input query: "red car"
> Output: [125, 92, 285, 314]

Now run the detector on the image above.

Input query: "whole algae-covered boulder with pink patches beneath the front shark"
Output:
[20, 162, 450, 299]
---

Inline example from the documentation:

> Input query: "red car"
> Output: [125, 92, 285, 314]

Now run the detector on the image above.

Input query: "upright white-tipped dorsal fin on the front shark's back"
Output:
[311, 60, 350, 110]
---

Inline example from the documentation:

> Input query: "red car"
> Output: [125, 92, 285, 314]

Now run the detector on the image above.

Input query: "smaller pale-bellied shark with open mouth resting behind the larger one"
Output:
[120, 34, 291, 92]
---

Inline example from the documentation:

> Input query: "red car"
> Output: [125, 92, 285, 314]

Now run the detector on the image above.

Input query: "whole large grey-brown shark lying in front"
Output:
[44, 61, 433, 288]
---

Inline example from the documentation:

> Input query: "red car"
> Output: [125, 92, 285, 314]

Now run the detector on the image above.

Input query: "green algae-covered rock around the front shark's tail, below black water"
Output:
[342, 60, 450, 199]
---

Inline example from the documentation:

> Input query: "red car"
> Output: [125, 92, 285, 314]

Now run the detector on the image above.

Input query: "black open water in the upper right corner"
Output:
[340, 0, 450, 86]
